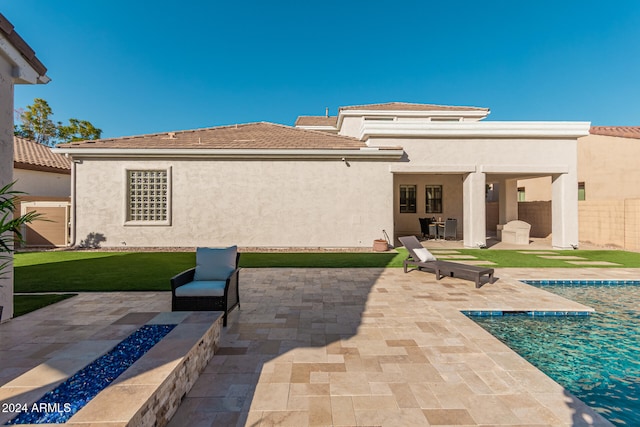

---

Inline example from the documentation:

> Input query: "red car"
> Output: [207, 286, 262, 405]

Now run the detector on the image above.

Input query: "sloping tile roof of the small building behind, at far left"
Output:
[13, 136, 71, 174]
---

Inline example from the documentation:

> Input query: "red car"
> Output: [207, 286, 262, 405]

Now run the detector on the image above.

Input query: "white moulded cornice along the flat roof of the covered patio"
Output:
[359, 121, 591, 141]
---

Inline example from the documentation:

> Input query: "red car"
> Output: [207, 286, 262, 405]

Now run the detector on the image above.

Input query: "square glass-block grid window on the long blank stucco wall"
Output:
[126, 169, 170, 225]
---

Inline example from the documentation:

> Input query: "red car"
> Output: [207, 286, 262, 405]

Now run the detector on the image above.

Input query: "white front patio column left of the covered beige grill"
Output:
[462, 172, 487, 248]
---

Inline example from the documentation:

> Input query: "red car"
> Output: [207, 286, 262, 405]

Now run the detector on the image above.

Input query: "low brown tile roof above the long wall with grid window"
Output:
[58, 122, 366, 150]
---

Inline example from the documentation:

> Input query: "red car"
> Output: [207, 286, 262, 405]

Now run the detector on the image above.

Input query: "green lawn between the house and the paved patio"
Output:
[14, 248, 640, 292]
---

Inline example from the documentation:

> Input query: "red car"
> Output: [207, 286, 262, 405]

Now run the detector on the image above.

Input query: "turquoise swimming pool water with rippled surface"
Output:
[464, 281, 640, 426]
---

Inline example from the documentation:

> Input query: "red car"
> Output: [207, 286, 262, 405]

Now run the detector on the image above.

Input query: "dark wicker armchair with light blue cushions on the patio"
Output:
[171, 246, 240, 326]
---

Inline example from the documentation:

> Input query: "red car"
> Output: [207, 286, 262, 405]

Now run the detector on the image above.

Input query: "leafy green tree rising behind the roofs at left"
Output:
[13, 98, 102, 146]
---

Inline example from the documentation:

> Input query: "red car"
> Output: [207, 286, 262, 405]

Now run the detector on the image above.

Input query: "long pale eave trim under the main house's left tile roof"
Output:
[52, 147, 404, 160]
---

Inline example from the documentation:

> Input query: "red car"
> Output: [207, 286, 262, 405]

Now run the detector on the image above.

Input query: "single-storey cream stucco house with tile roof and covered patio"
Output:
[54, 102, 589, 252]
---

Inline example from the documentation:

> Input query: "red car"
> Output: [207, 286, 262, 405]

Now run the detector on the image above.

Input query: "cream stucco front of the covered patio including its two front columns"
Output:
[384, 137, 578, 248]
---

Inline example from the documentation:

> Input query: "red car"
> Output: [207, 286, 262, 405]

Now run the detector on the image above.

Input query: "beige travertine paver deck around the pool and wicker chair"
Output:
[0, 268, 639, 427]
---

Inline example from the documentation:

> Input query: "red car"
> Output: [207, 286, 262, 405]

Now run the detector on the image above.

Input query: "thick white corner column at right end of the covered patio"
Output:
[551, 172, 578, 249]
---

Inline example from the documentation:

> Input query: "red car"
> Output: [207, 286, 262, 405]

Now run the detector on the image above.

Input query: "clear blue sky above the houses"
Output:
[5, 0, 640, 137]
